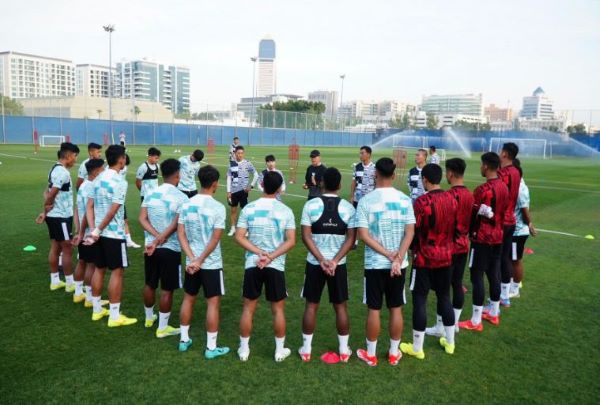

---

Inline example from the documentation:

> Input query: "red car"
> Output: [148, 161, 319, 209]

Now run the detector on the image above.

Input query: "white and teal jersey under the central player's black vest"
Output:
[300, 194, 355, 265]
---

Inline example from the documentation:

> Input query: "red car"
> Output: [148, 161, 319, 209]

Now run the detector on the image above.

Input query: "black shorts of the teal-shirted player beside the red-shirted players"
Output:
[363, 268, 406, 310]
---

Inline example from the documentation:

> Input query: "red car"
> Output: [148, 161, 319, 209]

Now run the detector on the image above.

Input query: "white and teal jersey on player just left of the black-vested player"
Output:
[237, 198, 296, 271]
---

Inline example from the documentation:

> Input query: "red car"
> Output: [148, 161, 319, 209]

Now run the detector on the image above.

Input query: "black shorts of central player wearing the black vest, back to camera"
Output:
[300, 262, 348, 304]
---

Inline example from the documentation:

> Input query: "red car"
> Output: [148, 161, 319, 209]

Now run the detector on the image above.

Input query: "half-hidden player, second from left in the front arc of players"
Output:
[73, 159, 108, 308]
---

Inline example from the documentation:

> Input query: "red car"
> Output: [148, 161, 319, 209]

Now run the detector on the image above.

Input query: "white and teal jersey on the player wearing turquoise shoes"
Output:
[179, 194, 226, 270]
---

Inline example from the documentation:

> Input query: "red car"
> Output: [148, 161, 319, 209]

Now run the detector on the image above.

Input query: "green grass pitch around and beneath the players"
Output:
[0, 145, 600, 403]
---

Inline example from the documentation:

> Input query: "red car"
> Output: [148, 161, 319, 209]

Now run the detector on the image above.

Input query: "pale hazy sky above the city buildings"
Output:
[0, 0, 600, 111]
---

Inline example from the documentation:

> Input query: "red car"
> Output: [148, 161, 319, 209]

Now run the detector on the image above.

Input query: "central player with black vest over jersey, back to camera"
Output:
[298, 167, 356, 363]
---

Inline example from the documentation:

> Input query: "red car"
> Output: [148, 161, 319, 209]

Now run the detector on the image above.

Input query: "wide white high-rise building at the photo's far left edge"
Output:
[0, 51, 75, 98]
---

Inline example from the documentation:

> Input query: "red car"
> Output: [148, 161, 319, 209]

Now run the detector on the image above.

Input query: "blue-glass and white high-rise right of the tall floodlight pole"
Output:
[117, 59, 190, 114]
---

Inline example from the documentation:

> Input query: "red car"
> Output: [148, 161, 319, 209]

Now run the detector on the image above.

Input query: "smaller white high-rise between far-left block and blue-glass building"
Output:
[75, 64, 121, 97]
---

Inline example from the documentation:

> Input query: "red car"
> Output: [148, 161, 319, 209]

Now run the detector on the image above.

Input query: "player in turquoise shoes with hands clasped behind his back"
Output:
[177, 166, 229, 359]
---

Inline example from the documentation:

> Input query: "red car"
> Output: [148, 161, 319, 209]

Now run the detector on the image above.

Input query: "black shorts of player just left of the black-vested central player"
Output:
[243, 267, 287, 302]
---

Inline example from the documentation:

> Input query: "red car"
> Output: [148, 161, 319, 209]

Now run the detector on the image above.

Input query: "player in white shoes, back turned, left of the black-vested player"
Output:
[235, 172, 296, 362]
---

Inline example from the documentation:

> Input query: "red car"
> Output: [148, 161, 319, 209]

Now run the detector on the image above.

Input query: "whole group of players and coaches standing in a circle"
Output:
[36, 139, 535, 366]
